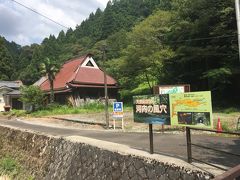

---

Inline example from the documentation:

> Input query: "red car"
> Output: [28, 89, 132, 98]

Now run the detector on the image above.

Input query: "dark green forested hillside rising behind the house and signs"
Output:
[0, 0, 240, 105]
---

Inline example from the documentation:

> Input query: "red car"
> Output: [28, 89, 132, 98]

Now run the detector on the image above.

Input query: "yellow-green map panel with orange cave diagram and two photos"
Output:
[170, 91, 213, 128]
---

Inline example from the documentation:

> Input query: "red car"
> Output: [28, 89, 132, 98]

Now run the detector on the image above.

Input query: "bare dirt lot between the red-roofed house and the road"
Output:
[20, 111, 240, 132]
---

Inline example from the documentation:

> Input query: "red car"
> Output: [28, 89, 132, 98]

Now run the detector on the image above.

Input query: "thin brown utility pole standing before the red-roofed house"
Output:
[102, 46, 109, 129]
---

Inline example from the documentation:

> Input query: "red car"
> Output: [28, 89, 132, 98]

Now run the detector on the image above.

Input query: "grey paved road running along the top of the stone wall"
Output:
[0, 119, 240, 167]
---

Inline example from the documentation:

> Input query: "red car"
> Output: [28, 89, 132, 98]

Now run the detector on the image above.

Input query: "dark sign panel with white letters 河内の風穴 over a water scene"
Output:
[133, 94, 170, 125]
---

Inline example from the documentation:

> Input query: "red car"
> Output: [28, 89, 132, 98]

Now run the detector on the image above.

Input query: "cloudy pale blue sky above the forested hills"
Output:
[0, 0, 108, 45]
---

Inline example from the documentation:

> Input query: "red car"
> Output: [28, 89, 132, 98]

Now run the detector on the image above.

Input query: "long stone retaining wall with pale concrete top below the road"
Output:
[0, 126, 213, 180]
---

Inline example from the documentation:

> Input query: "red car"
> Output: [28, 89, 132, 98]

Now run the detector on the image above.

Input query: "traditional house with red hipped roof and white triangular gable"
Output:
[35, 54, 118, 106]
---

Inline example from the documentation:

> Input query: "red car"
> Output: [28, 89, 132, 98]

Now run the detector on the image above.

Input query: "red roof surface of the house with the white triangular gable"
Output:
[40, 55, 117, 91]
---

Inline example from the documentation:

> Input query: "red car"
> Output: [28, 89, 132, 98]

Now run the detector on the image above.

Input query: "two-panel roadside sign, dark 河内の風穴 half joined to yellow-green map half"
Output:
[133, 91, 212, 127]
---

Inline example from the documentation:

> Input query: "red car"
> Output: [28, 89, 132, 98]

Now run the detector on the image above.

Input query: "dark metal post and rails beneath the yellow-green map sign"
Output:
[186, 127, 240, 170]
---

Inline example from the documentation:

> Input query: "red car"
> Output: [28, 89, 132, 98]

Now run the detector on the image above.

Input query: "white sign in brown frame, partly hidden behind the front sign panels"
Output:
[153, 84, 190, 94]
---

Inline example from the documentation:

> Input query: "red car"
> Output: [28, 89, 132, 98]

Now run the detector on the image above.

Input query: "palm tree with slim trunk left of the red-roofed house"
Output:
[40, 57, 59, 103]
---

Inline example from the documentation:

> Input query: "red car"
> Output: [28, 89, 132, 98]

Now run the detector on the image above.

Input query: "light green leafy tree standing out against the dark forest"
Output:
[116, 11, 174, 89]
